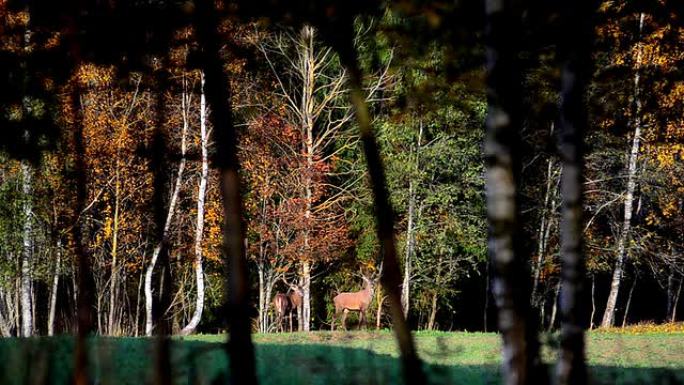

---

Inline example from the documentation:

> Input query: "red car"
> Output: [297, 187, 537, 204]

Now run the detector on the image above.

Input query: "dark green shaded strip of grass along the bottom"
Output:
[0, 337, 684, 385]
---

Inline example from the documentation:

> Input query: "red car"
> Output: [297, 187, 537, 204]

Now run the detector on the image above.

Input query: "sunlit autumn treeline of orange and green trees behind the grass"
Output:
[0, 2, 684, 336]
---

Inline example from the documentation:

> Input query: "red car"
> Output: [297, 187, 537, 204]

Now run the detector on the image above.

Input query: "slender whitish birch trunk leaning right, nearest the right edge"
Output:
[601, 12, 644, 327]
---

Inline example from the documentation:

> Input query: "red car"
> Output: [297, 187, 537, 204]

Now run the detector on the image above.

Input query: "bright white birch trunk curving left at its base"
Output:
[181, 73, 209, 335]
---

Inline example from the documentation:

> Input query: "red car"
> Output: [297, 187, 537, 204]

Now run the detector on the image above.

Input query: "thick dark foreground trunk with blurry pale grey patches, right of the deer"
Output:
[484, 0, 548, 385]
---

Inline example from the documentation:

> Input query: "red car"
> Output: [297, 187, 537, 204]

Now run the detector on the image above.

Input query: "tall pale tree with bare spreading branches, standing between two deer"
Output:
[259, 25, 390, 331]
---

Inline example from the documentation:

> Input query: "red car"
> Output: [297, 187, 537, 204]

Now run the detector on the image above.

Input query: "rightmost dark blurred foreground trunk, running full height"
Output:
[556, 0, 592, 385]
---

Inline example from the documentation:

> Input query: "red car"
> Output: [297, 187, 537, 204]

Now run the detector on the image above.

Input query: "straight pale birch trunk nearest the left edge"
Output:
[20, 159, 33, 337]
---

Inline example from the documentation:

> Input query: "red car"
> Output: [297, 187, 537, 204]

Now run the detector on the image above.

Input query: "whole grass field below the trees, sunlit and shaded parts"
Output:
[0, 331, 684, 385]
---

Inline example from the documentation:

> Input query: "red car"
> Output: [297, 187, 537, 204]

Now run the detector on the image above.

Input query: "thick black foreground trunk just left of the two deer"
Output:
[195, 0, 257, 385]
